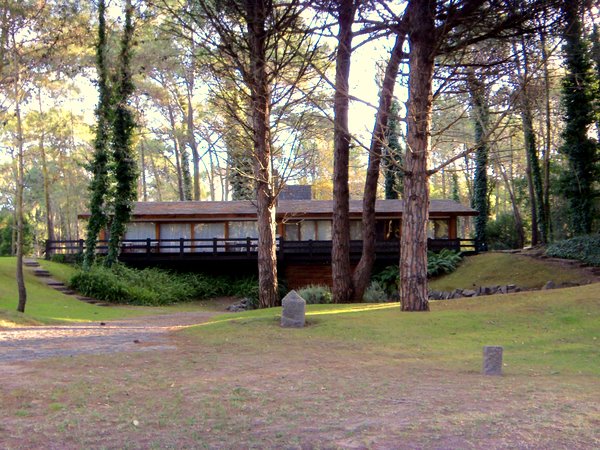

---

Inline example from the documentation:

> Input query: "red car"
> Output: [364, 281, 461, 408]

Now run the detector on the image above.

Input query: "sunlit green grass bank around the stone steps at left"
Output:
[0, 257, 214, 326]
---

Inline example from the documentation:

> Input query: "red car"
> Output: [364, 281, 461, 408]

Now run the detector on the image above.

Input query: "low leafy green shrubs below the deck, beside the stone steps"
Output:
[69, 264, 258, 306]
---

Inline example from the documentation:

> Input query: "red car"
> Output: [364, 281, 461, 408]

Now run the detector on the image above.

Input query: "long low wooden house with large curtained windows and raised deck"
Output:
[46, 197, 477, 288]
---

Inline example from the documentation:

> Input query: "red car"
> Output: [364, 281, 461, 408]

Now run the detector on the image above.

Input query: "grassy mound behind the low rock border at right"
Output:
[429, 252, 585, 291]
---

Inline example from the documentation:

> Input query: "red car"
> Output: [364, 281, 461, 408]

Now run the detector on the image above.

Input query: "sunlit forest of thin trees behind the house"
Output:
[0, 0, 600, 306]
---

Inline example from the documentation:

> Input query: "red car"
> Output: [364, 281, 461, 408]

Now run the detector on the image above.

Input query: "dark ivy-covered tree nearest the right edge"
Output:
[559, 1, 600, 234]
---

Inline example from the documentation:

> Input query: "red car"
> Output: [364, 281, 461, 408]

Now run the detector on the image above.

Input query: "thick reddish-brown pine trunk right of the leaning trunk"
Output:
[400, 0, 435, 311]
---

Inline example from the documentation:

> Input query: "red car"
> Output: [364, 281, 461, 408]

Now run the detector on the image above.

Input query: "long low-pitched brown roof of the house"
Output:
[79, 200, 477, 221]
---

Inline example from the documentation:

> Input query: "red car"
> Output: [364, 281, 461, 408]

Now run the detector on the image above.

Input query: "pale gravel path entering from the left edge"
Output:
[0, 312, 218, 364]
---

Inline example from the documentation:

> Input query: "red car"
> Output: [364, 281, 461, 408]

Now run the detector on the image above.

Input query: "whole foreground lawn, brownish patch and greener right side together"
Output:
[0, 284, 600, 449]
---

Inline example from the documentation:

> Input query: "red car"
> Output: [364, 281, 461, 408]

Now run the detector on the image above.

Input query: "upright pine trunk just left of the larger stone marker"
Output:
[246, 0, 279, 308]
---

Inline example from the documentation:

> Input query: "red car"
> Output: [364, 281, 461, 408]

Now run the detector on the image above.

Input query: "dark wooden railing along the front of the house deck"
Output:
[46, 237, 478, 259]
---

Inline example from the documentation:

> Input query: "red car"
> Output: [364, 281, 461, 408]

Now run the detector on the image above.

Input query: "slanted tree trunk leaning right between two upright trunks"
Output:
[353, 34, 404, 301]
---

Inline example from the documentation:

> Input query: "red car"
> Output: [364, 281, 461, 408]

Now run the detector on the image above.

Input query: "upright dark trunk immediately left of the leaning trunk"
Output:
[331, 0, 356, 303]
